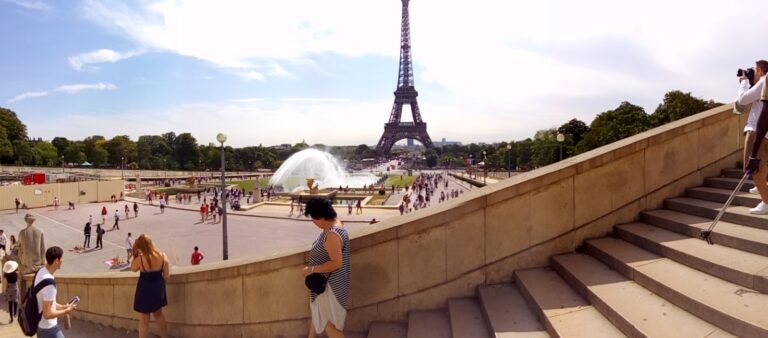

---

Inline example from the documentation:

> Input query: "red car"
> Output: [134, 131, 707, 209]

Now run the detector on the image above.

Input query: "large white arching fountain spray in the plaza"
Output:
[269, 148, 379, 193]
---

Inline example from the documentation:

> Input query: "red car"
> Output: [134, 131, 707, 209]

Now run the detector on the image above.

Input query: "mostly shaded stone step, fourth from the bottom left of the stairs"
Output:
[478, 284, 549, 338]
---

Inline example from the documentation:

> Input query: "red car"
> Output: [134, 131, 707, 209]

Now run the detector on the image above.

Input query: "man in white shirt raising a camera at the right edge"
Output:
[736, 60, 768, 215]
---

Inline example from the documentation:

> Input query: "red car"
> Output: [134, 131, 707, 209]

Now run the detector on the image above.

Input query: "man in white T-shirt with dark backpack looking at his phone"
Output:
[19, 246, 77, 338]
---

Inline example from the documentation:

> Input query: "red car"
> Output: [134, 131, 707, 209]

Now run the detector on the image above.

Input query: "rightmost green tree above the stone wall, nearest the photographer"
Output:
[651, 90, 722, 127]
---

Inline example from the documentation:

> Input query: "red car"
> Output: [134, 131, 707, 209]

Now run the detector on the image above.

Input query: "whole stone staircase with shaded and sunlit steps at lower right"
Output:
[364, 169, 768, 338]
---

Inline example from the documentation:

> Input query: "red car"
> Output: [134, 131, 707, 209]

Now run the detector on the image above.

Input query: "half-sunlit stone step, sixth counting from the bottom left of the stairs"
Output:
[552, 253, 732, 337]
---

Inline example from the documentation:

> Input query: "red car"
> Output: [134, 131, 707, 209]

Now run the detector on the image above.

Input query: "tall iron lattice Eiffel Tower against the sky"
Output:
[376, 0, 433, 156]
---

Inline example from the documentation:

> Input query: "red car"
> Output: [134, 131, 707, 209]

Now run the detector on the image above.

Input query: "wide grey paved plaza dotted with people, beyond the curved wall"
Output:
[0, 198, 399, 274]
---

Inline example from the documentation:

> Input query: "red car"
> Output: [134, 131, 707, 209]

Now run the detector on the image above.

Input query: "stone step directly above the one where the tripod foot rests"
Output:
[664, 197, 768, 230]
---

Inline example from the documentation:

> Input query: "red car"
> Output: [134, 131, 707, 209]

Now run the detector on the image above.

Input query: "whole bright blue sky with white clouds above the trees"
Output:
[0, 0, 768, 146]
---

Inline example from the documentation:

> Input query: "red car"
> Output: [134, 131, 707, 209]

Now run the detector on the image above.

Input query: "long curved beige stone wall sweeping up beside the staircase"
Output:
[57, 105, 746, 337]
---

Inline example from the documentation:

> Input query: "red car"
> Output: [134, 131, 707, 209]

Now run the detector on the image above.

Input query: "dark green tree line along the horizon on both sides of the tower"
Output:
[0, 90, 721, 170]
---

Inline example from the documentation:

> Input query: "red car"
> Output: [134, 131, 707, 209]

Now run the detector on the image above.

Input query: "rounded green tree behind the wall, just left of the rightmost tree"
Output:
[576, 102, 651, 153]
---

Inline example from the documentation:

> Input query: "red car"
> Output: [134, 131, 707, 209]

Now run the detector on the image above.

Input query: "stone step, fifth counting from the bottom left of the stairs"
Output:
[515, 268, 625, 337]
